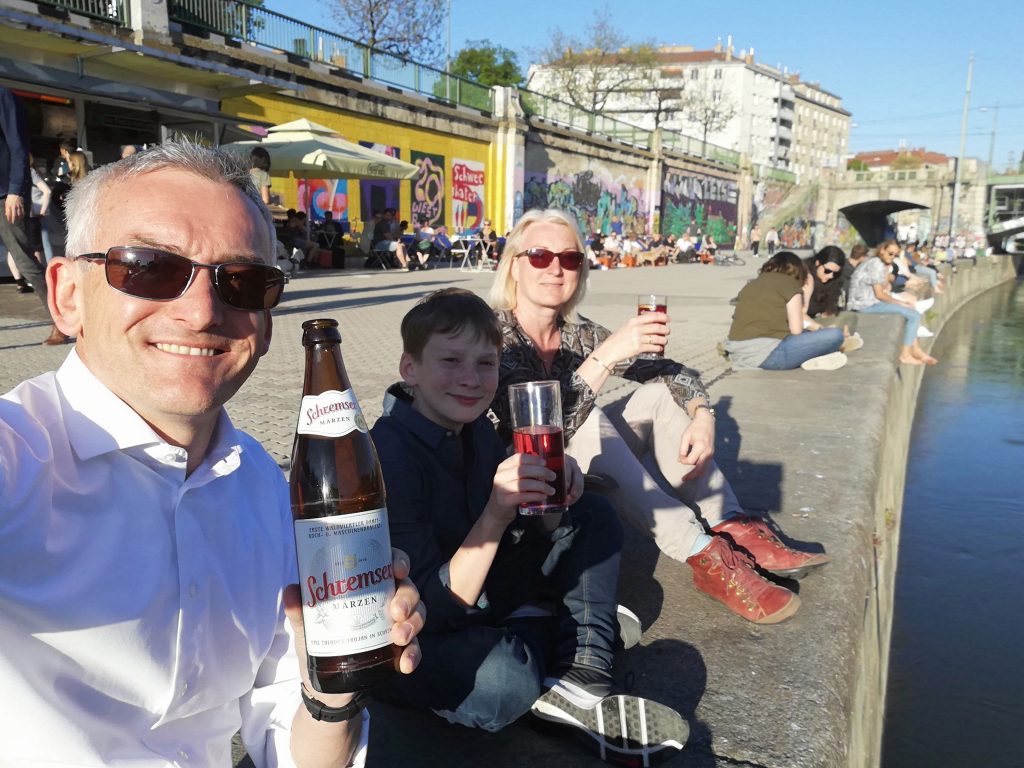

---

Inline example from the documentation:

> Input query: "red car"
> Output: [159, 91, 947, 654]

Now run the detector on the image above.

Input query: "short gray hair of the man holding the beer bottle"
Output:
[65, 139, 276, 264]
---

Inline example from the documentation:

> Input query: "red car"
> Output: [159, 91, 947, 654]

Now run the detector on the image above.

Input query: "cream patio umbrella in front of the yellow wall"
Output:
[221, 120, 417, 179]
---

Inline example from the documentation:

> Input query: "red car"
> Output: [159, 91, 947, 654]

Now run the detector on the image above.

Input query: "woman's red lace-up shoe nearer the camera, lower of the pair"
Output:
[686, 536, 800, 624]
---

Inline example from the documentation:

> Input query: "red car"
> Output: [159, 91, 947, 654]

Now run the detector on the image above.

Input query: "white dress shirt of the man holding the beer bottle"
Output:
[0, 351, 367, 768]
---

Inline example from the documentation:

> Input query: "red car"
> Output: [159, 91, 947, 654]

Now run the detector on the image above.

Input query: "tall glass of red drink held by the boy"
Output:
[509, 381, 567, 515]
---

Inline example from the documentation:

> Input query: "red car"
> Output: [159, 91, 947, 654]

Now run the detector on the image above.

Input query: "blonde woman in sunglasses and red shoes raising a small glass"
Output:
[489, 210, 827, 624]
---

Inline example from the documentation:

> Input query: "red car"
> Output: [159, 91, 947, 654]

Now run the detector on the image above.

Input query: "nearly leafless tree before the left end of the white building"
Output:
[527, 8, 654, 113]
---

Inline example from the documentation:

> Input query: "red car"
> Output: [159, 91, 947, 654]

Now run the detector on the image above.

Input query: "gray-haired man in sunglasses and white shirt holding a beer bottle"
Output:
[0, 143, 422, 768]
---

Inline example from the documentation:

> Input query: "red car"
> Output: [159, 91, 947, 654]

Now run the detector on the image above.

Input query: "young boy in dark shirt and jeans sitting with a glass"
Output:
[372, 288, 688, 765]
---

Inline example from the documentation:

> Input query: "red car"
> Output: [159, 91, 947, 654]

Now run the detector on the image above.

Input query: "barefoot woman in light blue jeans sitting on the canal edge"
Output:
[846, 240, 938, 366]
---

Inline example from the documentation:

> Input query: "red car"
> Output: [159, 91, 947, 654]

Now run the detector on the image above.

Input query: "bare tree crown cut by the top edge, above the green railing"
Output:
[328, 0, 445, 65]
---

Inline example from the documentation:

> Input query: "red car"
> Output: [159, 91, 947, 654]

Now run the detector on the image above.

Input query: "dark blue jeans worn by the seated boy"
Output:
[376, 494, 623, 731]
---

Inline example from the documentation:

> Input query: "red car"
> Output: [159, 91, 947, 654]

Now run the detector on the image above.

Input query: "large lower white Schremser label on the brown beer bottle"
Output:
[295, 507, 394, 656]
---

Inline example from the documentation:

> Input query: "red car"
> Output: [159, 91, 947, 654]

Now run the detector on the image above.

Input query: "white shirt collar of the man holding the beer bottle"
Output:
[56, 349, 242, 474]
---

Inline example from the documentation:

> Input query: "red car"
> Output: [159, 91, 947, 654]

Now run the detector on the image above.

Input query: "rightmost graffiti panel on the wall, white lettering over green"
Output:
[660, 170, 739, 248]
